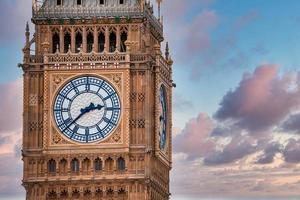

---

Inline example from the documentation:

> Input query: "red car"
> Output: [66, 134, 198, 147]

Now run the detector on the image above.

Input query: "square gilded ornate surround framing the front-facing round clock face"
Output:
[45, 70, 129, 148]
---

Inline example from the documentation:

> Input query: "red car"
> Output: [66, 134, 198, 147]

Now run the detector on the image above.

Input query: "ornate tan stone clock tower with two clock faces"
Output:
[20, 0, 174, 200]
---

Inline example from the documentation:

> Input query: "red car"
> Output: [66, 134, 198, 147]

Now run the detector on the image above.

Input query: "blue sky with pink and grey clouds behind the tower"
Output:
[0, 0, 300, 200]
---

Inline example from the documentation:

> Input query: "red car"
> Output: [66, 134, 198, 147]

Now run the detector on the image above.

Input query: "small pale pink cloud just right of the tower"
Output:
[173, 113, 215, 159]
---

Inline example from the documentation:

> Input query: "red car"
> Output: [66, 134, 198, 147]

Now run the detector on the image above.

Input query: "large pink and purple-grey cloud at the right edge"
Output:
[214, 64, 300, 134]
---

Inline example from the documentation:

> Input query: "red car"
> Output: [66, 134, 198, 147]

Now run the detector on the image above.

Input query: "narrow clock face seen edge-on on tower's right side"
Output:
[159, 85, 167, 150]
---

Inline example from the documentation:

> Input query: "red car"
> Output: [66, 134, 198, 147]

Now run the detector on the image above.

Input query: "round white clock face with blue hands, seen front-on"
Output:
[53, 76, 121, 143]
